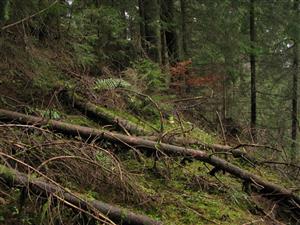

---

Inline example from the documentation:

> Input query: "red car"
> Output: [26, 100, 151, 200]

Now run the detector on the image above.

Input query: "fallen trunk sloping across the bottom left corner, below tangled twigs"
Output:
[0, 164, 162, 225]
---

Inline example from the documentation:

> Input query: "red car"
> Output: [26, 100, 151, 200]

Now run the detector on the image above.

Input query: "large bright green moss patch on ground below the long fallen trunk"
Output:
[123, 158, 255, 225]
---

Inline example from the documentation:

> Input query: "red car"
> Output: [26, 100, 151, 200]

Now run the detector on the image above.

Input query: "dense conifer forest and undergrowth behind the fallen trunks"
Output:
[0, 0, 300, 224]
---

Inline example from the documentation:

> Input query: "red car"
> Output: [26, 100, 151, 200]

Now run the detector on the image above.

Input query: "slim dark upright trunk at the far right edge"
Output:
[291, 0, 299, 161]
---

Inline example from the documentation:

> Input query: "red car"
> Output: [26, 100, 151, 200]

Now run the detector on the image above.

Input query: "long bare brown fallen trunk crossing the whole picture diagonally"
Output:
[0, 109, 300, 208]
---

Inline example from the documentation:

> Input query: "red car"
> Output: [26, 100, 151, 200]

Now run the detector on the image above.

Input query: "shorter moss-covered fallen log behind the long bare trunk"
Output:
[59, 90, 153, 135]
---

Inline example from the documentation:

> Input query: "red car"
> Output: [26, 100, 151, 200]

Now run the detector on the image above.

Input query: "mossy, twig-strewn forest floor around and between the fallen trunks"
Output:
[0, 40, 300, 225]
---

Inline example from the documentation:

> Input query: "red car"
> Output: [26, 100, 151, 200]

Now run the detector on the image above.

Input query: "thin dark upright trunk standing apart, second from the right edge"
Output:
[250, 0, 257, 141]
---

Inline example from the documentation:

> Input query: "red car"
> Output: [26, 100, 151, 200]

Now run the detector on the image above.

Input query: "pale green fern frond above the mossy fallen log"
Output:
[94, 78, 131, 91]
